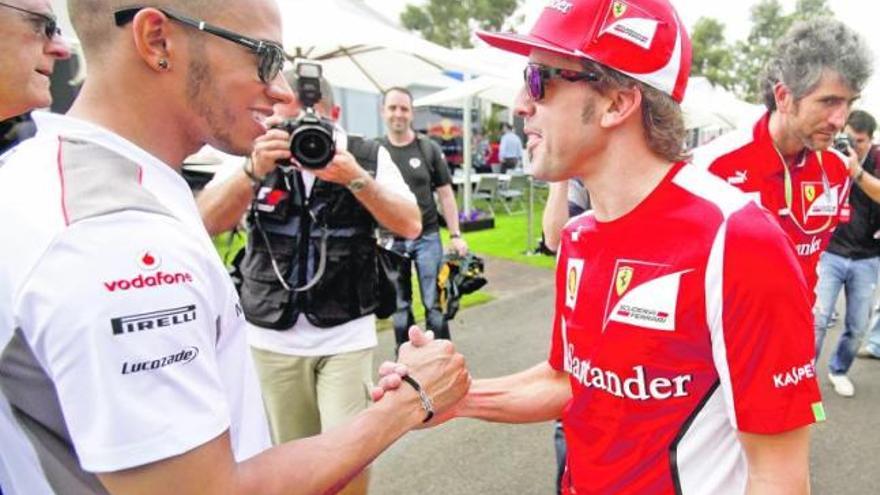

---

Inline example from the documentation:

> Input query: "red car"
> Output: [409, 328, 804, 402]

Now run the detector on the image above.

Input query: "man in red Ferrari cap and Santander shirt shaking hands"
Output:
[383, 0, 824, 495]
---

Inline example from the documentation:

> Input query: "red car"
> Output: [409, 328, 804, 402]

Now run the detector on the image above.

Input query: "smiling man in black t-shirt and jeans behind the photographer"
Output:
[381, 88, 467, 347]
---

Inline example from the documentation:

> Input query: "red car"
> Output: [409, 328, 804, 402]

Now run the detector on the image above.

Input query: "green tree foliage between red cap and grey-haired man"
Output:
[691, 0, 834, 103]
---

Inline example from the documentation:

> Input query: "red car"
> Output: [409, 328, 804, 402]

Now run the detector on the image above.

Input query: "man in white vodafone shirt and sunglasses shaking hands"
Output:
[0, 0, 468, 494]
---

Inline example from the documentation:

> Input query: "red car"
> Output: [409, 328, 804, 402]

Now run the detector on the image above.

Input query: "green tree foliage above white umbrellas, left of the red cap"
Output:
[400, 0, 522, 48]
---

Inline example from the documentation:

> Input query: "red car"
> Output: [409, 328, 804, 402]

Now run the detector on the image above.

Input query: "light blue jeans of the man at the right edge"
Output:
[813, 252, 880, 375]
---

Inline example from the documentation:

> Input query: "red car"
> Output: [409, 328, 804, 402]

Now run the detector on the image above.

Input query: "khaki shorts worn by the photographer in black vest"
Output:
[251, 348, 373, 445]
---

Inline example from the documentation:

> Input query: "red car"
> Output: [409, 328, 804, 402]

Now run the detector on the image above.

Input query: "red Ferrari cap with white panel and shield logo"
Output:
[477, 0, 691, 103]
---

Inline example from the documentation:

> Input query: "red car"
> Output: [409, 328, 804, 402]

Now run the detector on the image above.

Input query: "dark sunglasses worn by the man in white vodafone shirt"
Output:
[113, 6, 285, 84]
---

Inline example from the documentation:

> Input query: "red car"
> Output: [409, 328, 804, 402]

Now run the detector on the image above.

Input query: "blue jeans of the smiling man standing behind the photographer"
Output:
[391, 232, 450, 347]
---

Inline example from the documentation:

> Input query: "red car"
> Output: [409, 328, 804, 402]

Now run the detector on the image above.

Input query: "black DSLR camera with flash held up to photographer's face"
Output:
[276, 61, 336, 170]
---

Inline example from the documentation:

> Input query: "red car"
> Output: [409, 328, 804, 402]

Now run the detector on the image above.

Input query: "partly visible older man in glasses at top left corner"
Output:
[0, 0, 70, 120]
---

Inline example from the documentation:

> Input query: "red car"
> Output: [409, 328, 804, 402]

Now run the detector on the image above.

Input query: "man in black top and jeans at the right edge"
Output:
[814, 110, 880, 397]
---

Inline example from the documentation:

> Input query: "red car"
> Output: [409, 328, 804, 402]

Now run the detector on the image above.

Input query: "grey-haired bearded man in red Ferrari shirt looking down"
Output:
[694, 19, 880, 302]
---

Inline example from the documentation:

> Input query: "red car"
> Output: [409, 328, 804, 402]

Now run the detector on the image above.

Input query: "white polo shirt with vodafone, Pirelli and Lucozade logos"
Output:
[0, 114, 270, 488]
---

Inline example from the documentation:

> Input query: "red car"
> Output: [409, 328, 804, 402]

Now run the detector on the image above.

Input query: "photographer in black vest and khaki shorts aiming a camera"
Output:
[198, 64, 421, 493]
